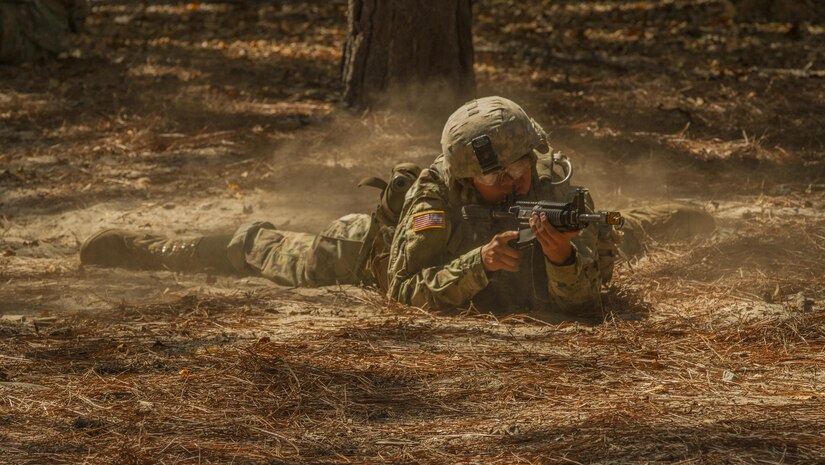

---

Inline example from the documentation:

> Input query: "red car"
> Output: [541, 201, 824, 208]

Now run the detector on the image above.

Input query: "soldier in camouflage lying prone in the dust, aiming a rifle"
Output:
[80, 97, 714, 313]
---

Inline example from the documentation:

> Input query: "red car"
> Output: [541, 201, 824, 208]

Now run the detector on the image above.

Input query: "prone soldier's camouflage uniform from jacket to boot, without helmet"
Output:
[81, 156, 715, 313]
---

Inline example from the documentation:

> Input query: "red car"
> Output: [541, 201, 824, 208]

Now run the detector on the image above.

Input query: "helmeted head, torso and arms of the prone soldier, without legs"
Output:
[389, 97, 600, 312]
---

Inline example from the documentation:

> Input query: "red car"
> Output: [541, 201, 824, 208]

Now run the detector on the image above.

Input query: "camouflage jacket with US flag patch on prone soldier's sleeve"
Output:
[388, 156, 615, 313]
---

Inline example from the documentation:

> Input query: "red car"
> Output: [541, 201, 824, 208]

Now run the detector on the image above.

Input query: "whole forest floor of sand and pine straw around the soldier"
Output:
[0, 0, 825, 464]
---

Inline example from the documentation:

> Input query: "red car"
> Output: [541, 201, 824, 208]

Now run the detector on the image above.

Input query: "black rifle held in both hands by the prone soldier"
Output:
[461, 187, 624, 249]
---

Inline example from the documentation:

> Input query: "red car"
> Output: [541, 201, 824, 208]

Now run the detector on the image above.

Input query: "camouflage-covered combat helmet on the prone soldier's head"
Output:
[441, 97, 549, 179]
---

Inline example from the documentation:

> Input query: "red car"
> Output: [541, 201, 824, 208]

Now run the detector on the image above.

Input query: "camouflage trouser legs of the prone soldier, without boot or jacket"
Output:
[228, 204, 716, 287]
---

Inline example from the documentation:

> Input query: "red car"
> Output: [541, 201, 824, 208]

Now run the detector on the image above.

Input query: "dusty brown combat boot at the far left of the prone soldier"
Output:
[80, 229, 233, 273]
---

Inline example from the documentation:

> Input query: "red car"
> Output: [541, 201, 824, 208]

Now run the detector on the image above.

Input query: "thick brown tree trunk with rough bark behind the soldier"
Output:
[341, 0, 475, 109]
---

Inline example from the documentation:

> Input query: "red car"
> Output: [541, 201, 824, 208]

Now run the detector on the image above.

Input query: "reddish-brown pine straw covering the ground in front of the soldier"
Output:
[0, 258, 825, 464]
